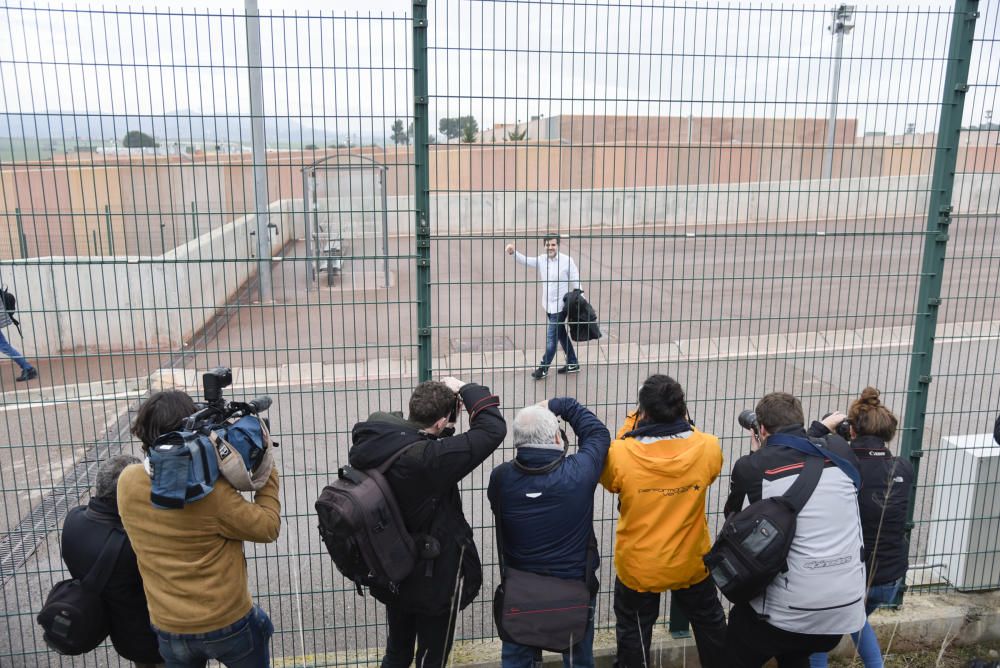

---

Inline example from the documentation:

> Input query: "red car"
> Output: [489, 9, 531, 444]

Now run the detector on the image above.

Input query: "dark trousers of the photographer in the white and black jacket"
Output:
[726, 603, 841, 668]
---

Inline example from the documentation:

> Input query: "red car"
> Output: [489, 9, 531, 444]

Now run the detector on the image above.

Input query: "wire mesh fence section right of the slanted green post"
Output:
[914, 3, 1000, 590]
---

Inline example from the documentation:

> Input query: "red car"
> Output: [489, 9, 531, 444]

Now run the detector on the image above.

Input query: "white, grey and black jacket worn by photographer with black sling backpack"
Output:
[725, 426, 866, 635]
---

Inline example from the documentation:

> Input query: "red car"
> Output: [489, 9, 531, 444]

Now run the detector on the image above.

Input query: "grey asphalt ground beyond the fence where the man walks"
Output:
[0, 214, 998, 665]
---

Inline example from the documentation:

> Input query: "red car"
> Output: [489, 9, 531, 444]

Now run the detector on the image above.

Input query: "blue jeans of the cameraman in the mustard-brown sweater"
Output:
[154, 605, 274, 668]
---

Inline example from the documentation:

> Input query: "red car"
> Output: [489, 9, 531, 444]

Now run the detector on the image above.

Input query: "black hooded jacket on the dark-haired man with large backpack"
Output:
[348, 383, 507, 615]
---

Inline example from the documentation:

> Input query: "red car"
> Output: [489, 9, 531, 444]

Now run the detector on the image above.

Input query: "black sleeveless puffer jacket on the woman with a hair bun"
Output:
[809, 422, 913, 585]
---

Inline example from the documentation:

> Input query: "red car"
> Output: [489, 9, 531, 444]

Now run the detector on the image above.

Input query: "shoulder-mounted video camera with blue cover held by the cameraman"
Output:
[149, 367, 278, 508]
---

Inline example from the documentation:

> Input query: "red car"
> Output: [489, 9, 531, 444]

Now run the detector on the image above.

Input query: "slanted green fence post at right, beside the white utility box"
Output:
[896, 0, 979, 604]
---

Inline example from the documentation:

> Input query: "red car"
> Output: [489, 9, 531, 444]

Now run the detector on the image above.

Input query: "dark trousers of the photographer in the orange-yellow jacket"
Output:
[615, 577, 726, 668]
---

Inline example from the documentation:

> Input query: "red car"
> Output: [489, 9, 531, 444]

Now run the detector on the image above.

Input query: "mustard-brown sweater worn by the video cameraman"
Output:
[118, 464, 281, 633]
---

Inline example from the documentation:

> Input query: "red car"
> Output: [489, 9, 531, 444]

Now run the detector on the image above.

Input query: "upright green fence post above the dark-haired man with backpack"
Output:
[413, 0, 433, 381]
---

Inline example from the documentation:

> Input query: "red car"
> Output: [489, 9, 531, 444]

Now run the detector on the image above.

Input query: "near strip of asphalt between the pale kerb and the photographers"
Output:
[0, 340, 1000, 665]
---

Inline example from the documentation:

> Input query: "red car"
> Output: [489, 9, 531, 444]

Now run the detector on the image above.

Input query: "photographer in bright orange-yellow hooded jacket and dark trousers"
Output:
[601, 374, 726, 668]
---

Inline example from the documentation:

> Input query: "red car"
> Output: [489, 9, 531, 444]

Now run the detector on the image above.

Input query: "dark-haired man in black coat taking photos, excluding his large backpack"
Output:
[348, 377, 507, 668]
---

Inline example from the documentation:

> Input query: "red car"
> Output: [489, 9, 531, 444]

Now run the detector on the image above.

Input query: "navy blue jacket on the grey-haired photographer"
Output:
[487, 397, 611, 580]
